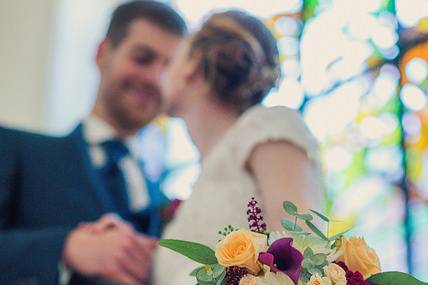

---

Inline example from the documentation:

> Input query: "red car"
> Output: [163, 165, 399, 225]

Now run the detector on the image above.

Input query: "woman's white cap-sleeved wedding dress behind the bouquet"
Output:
[154, 106, 319, 285]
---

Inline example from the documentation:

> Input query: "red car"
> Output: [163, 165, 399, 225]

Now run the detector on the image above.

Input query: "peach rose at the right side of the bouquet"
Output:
[337, 237, 380, 279]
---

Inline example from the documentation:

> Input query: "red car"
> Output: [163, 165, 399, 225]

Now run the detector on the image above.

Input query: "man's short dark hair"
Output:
[106, 0, 187, 46]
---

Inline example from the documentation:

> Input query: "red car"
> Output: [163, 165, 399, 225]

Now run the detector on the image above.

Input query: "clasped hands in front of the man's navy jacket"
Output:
[63, 216, 156, 284]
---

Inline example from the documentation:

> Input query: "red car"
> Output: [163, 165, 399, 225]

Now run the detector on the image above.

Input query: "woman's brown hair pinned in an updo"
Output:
[190, 10, 280, 113]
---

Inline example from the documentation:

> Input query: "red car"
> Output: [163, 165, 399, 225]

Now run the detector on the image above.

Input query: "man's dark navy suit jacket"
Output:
[0, 127, 159, 285]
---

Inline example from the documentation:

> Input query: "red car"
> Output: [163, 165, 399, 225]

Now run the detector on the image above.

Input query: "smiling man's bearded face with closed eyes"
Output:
[96, 20, 180, 130]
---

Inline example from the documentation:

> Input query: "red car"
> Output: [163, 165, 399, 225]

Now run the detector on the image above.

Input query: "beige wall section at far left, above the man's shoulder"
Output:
[0, 0, 56, 129]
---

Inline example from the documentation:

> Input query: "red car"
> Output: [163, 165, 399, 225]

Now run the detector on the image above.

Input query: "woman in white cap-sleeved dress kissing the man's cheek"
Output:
[153, 10, 321, 285]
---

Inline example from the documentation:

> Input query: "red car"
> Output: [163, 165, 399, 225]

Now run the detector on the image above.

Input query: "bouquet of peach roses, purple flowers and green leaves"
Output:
[160, 198, 428, 285]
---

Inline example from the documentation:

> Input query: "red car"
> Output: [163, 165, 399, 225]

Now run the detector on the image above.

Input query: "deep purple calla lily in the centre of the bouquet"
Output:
[259, 238, 303, 284]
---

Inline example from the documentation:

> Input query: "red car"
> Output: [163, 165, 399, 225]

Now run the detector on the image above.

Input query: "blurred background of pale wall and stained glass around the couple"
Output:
[0, 0, 428, 280]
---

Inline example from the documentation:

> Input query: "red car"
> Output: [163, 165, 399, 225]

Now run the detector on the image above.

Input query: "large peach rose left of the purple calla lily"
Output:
[215, 229, 267, 274]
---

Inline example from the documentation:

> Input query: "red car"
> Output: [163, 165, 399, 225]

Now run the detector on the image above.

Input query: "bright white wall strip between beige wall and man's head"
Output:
[47, 0, 124, 134]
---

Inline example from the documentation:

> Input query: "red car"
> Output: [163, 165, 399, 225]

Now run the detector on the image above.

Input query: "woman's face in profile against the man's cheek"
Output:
[161, 38, 191, 115]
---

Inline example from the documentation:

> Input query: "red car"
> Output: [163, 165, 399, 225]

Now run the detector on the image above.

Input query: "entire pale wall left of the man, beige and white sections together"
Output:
[0, 0, 127, 133]
